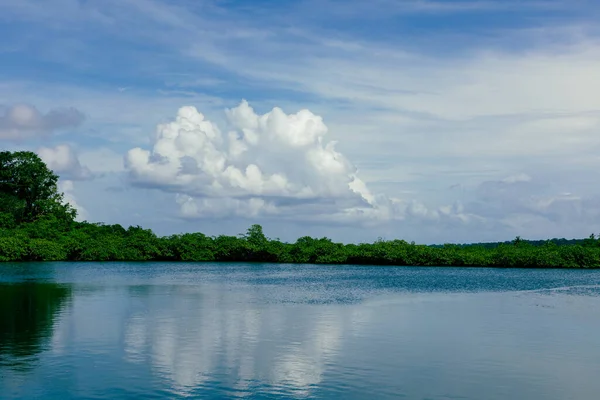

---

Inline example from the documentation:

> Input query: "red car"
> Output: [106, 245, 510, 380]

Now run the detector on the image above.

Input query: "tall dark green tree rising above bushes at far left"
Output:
[0, 151, 76, 224]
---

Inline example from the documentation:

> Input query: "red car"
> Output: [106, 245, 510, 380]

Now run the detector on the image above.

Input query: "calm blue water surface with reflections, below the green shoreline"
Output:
[0, 263, 600, 400]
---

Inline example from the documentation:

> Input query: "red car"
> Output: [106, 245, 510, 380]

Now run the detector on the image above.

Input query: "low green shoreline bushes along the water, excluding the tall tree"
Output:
[0, 217, 600, 268]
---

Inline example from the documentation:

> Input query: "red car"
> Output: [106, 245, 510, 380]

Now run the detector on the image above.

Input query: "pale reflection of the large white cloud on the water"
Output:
[118, 286, 366, 396]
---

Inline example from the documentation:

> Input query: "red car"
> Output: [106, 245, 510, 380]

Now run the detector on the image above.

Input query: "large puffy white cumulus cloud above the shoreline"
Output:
[125, 101, 476, 222]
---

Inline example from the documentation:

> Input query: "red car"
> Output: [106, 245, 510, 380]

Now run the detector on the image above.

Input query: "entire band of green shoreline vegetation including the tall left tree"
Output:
[0, 152, 600, 268]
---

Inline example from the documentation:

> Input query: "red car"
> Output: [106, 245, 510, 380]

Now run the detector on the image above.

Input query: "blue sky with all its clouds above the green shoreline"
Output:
[0, 0, 600, 244]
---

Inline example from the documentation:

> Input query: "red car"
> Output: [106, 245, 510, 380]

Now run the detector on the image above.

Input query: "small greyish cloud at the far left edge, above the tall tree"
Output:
[0, 104, 84, 141]
